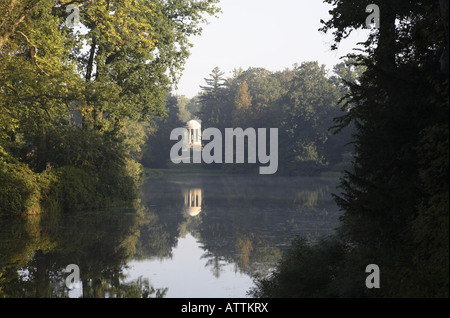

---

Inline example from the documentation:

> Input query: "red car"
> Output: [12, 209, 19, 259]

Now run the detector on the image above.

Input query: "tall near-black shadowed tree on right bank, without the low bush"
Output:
[322, 0, 448, 297]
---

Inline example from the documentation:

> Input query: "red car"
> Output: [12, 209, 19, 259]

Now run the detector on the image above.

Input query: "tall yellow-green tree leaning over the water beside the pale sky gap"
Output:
[62, 0, 218, 130]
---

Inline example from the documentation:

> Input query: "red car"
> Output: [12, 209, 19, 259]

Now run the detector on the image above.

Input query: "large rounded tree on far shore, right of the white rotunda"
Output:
[278, 62, 339, 172]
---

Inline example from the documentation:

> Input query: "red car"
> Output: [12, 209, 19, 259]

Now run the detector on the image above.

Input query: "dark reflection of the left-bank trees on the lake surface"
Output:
[0, 211, 165, 298]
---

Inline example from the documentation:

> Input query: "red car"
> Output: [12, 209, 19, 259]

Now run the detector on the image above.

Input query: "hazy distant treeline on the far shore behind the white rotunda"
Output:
[144, 61, 363, 175]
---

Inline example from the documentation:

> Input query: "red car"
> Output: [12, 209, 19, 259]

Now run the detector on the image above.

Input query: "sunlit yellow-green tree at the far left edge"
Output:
[0, 1, 81, 171]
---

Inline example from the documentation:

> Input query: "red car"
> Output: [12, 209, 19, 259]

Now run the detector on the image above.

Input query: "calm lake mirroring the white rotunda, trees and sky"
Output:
[0, 174, 341, 298]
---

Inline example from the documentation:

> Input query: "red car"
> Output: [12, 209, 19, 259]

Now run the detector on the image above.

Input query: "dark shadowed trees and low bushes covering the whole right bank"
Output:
[251, 0, 449, 297]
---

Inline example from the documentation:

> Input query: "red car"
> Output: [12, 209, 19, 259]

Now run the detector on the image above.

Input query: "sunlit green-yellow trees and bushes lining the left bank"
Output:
[0, 0, 218, 217]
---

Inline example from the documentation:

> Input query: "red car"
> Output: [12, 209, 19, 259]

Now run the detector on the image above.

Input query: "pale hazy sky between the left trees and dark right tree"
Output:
[175, 0, 367, 97]
